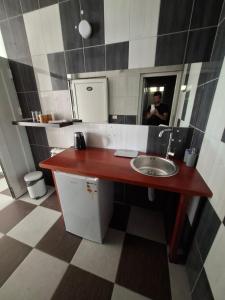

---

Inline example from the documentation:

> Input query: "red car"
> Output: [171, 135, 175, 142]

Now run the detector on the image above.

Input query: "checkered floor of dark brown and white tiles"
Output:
[0, 185, 190, 300]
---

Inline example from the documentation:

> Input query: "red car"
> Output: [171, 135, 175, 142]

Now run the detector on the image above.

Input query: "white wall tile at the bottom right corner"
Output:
[204, 224, 225, 300]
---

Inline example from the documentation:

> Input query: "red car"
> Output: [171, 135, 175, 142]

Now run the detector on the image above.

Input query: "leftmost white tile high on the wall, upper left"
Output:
[23, 10, 46, 55]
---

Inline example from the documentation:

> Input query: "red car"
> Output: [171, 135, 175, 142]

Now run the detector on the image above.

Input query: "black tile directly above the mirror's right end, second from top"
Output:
[155, 32, 187, 66]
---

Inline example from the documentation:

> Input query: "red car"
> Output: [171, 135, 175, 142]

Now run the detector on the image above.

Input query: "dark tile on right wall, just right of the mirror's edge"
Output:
[190, 80, 218, 131]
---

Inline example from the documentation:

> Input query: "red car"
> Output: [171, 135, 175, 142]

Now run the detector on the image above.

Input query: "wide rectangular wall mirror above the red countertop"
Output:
[67, 65, 183, 126]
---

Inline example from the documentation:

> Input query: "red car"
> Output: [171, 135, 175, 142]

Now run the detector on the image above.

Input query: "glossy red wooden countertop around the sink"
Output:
[39, 148, 212, 197]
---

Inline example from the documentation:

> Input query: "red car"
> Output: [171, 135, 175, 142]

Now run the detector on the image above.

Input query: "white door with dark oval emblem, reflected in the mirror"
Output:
[72, 78, 108, 123]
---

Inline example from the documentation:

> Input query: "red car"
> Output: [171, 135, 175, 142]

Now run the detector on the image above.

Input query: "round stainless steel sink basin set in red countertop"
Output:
[130, 155, 179, 177]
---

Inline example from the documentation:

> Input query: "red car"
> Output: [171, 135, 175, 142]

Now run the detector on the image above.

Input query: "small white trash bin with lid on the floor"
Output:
[24, 171, 47, 199]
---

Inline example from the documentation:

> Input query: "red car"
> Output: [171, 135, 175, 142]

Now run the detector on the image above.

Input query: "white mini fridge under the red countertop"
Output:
[54, 171, 113, 243]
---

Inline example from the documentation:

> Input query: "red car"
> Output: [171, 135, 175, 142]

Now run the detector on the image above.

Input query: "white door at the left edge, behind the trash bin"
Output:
[0, 58, 35, 198]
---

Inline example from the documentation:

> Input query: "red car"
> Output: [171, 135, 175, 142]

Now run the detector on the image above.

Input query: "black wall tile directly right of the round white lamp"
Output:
[80, 0, 105, 47]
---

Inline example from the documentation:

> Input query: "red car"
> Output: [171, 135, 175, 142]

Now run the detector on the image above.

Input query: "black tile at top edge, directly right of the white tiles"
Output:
[158, 0, 193, 34]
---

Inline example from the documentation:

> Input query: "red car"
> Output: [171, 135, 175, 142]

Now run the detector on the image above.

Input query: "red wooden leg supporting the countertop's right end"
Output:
[169, 194, 188, 263]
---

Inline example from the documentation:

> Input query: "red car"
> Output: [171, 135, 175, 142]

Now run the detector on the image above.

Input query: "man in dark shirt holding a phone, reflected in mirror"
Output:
[146, 92, 169, 126]
